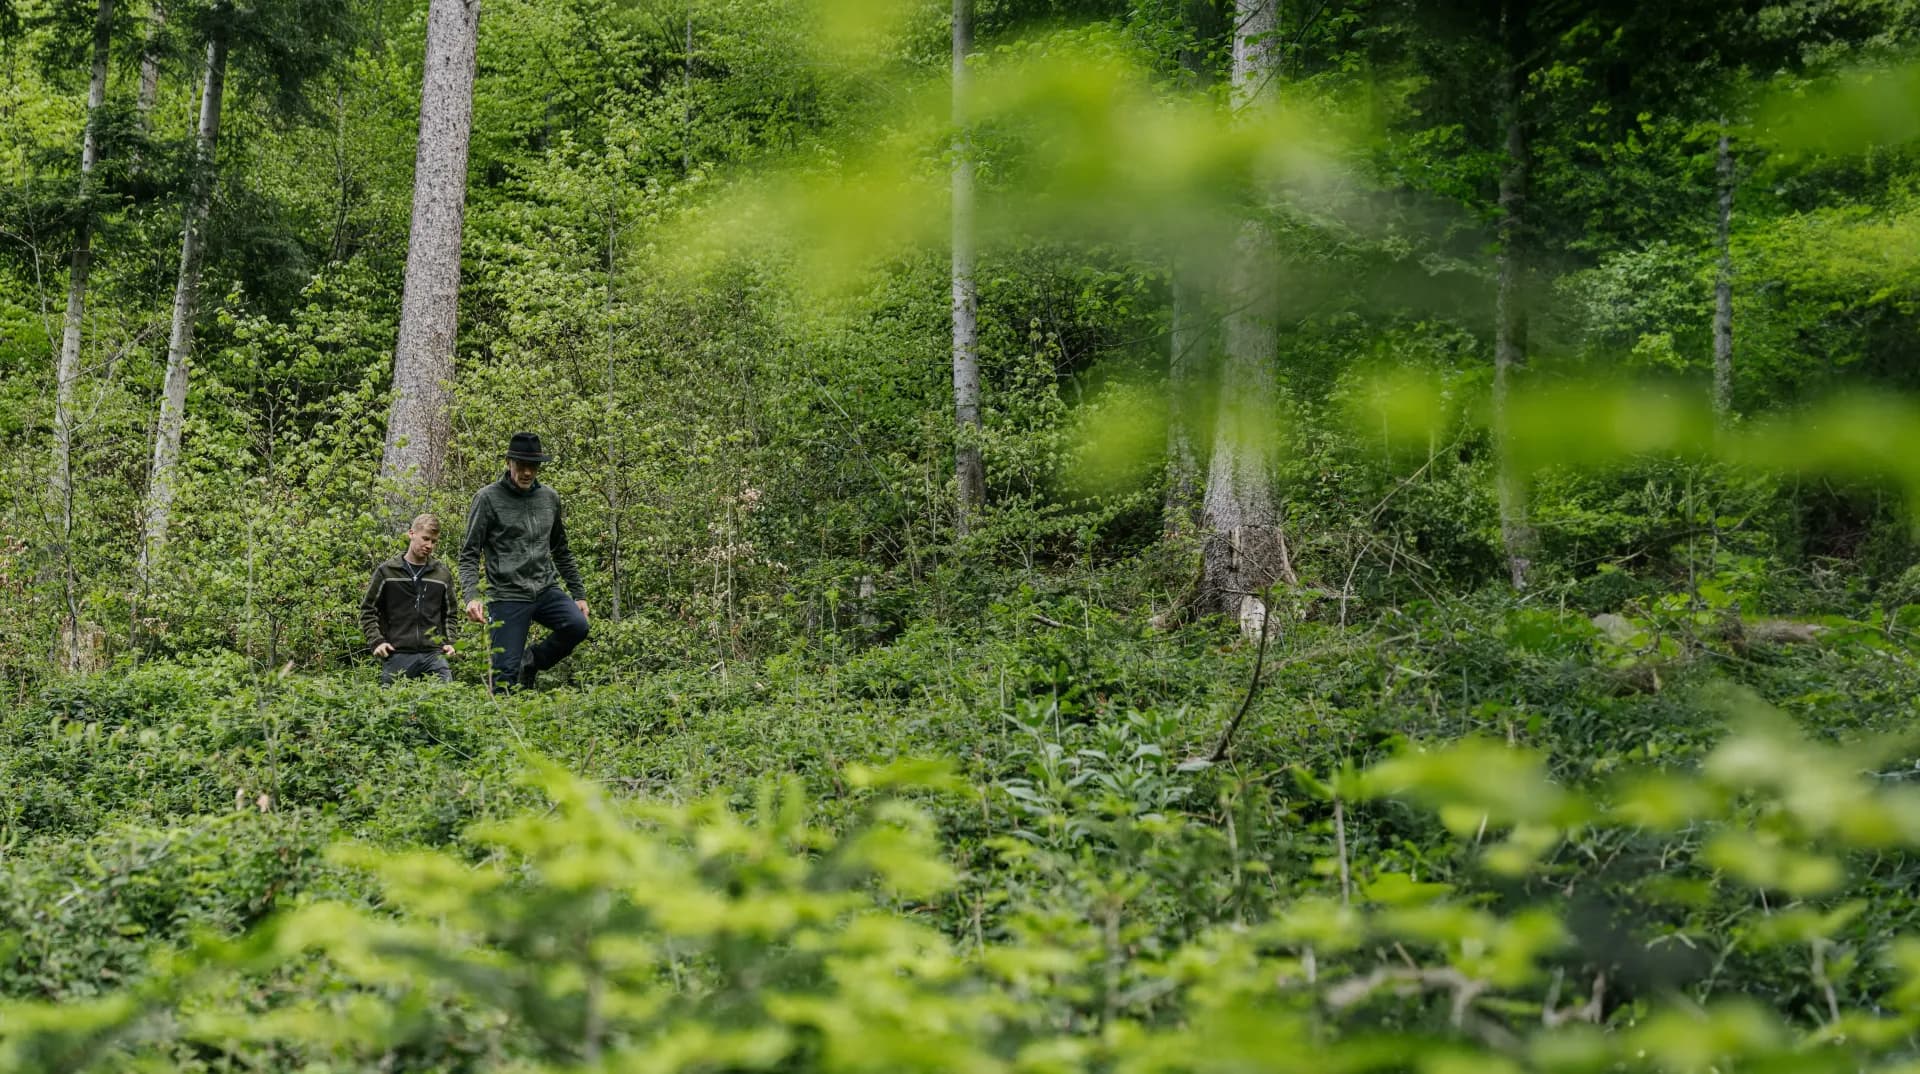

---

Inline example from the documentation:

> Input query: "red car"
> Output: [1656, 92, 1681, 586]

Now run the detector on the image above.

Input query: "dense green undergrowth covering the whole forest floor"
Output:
[11, 576, 1920, 1070]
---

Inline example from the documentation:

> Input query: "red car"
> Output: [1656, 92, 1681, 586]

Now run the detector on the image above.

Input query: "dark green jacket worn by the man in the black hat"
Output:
[461, 475, 588, 599]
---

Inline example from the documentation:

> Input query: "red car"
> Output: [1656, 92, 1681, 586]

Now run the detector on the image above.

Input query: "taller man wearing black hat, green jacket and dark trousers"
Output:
[461, 432, 588, 690]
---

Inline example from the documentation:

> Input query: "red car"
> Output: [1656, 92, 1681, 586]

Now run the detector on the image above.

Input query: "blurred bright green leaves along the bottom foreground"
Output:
[18, 694, 1920, 1074]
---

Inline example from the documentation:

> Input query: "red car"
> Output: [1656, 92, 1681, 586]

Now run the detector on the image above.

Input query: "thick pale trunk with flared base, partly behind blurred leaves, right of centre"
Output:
[1202, 0, 1292, 634]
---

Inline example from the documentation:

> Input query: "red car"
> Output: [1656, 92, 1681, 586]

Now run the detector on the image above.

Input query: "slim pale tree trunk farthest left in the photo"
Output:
[54, 0, 113, 669]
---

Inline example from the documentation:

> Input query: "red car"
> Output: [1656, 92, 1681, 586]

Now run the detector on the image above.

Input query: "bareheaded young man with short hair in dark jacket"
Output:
[361, 515, 457, 686]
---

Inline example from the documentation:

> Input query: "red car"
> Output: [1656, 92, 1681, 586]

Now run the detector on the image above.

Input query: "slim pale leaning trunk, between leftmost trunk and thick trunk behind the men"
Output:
[140, 31, 227, 580]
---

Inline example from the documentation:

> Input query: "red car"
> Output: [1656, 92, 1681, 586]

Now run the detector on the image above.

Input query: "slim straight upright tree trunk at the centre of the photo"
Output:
[952, 0, 987, 536]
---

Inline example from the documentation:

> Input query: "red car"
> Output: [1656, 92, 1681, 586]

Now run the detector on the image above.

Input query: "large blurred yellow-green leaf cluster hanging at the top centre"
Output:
[670, 27, 1356, 290]
